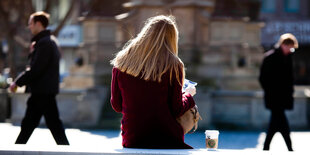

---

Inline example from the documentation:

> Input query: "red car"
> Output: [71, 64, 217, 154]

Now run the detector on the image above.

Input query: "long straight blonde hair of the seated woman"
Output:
[111, 15, 185, 85]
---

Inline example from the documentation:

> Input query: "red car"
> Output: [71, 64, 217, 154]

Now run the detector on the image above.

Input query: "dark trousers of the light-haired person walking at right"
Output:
[264, 110, 293, 151]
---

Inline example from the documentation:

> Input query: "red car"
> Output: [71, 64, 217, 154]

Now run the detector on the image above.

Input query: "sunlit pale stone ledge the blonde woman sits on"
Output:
[0, 145, 278, 155]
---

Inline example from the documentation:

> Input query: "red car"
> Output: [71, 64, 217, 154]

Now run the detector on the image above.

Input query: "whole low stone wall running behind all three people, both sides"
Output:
[4, 88, 310, 130]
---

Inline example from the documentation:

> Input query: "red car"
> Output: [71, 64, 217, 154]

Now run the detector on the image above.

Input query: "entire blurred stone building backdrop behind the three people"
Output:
[0, 0, 310, 129]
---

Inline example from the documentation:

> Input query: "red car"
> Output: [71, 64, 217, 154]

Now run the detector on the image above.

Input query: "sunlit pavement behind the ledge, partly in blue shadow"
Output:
[0, 123, 310, 153]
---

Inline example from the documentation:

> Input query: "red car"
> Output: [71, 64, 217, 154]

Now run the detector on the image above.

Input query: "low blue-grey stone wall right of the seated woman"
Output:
[195, 89, 309, 130]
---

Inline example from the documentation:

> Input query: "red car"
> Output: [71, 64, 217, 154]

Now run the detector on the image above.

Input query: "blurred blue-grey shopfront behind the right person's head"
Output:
[260, 0, 310, 85]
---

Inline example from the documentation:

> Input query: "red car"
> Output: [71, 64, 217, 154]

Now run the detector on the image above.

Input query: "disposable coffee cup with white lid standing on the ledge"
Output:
[205, 130, 219, 150]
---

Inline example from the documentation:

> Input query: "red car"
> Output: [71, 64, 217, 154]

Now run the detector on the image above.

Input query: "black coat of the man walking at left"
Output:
[15, 30, 60, 94]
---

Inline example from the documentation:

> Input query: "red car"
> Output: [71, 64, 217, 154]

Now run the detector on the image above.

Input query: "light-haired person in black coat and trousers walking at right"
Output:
[259, 33, 298, 151]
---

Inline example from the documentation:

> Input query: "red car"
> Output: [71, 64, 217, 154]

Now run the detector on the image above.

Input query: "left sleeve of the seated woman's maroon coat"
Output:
[111, 68, 122, 112]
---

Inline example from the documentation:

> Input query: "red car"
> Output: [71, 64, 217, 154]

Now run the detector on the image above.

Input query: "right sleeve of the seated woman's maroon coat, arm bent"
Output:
[171, 68, 195, 118]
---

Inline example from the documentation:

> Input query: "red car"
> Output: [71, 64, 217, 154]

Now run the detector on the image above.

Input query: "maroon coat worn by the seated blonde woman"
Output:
[111, 68, 195, 149]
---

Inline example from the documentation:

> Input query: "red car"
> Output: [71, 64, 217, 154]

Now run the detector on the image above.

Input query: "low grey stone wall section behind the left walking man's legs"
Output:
[10, 88, 108, 127]
